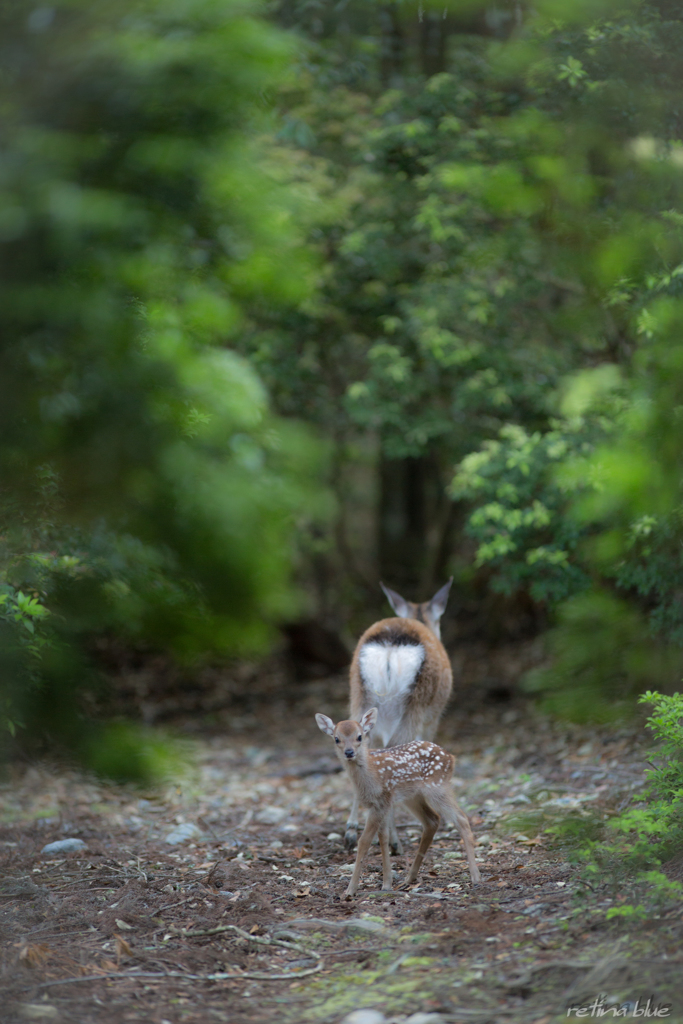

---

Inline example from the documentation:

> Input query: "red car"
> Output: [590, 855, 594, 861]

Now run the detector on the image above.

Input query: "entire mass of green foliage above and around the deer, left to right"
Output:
[6, 0, 683, 765]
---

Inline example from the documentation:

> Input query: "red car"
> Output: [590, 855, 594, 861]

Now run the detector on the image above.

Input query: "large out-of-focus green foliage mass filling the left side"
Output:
[0, 0, 324, 770]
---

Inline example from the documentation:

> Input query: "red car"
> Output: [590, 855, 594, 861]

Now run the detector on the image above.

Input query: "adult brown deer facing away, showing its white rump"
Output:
[344, 577, 453, 853]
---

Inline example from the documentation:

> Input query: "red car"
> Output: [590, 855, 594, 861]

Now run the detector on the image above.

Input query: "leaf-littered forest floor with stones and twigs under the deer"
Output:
[0, 678, 683, 1024]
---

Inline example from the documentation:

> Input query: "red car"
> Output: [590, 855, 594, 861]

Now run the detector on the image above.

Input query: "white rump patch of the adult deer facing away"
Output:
[358, 640, 425, 746]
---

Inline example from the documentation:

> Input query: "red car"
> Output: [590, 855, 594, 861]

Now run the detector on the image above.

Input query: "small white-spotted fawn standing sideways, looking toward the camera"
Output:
[315, 708, 480, 896]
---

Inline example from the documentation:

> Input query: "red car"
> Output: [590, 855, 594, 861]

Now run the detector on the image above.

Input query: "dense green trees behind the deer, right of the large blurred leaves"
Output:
[244, 0, 683, 709]
